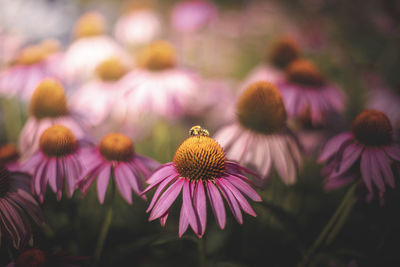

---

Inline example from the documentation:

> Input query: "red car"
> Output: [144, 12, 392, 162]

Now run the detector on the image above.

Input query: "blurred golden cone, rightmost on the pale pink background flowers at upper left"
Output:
[138, 41, 176, 71]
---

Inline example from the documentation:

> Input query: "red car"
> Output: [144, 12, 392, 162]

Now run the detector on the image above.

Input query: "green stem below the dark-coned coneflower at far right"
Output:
[298, 183, 357, 267]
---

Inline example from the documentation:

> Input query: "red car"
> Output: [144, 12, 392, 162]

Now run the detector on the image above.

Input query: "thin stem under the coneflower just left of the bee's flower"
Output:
[93, 174, 115, 266]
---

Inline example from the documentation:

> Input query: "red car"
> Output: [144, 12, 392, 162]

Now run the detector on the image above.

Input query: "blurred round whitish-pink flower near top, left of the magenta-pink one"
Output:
[114, 8, 161, 47]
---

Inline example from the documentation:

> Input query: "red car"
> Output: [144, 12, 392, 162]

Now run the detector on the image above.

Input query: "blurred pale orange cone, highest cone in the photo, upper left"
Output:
[75, 12, 107, 38]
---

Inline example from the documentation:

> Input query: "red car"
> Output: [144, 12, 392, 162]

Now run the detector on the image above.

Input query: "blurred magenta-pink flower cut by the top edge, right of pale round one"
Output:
[171, 0, 218, 32]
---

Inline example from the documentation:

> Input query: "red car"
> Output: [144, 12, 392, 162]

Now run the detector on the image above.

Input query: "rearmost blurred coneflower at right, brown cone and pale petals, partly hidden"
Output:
[241, 37, 300, 90]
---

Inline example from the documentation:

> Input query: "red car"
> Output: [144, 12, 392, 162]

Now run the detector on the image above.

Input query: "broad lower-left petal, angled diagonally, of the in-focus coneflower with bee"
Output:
[149, 178, 185, 221]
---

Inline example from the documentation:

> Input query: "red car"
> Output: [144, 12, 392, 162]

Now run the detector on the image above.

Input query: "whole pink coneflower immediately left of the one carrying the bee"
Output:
[79, 133, 159, 204]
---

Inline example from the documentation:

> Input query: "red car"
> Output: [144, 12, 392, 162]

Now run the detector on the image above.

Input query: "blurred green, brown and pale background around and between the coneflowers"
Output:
[0, 0, 400, 267]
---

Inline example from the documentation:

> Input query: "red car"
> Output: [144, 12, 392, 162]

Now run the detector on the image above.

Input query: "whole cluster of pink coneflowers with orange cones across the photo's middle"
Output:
[0, 1, 400, 266]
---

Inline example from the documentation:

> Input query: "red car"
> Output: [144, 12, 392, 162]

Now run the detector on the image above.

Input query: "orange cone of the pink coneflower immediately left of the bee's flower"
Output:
[100, 133, 135, 161]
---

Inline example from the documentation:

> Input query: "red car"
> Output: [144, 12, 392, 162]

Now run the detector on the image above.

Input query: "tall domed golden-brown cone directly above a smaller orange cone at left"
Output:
[29, 78, 68, 119]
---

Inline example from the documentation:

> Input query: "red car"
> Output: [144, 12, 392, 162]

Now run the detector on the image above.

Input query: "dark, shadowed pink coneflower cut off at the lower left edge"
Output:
[0, 166, 43, 249]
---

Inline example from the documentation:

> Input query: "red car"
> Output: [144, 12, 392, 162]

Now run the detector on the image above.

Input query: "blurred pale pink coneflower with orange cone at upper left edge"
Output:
[0, 40, 62, 100]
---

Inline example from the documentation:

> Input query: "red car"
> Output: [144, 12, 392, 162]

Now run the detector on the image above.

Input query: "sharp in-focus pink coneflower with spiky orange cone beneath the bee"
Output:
[143, 129, 261, 238]
